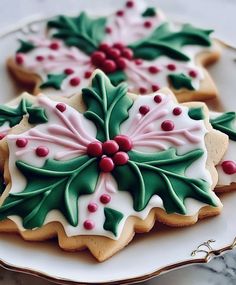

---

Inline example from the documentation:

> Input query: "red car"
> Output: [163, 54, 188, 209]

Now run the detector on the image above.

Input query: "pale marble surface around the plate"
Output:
[0, 0, 236, 285]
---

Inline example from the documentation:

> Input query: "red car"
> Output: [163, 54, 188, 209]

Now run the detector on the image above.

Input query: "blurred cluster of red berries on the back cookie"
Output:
[91, 43, 133, 73]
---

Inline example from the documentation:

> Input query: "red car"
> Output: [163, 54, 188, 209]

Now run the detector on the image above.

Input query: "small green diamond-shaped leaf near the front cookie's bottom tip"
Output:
[103, 207, 124, 236]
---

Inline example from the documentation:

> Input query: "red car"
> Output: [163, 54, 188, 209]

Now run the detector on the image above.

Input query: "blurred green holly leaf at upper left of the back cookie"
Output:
[48, 12, 106, 54]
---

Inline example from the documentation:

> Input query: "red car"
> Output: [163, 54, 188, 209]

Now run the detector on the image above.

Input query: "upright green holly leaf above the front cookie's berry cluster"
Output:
[82, 72, 133, 141]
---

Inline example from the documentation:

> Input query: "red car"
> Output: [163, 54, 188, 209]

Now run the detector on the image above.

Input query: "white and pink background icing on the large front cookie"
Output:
[4, 94, 221, 239]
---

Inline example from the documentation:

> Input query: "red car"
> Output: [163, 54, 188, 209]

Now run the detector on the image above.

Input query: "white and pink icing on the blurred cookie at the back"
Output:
[14, 3, 209, 96]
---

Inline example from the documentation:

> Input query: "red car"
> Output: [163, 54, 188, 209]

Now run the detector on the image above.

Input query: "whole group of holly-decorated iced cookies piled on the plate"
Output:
[0, 0, 233, 261]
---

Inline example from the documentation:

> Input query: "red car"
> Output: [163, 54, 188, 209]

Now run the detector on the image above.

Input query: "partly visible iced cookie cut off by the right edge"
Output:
[210, 112, 236, 192]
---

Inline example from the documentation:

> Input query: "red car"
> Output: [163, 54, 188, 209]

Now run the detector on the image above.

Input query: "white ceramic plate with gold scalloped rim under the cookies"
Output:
[0, 17, 236, 284]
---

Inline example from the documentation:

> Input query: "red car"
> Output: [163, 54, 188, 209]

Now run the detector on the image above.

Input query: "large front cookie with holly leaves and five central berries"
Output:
[0, 71, 228, 261]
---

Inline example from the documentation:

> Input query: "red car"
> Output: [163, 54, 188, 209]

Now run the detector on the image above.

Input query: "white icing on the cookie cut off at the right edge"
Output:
[210, 112, 236, 186]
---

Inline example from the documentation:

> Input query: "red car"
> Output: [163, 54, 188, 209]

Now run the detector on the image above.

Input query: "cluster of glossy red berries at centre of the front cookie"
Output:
[87, 135, 132, 172]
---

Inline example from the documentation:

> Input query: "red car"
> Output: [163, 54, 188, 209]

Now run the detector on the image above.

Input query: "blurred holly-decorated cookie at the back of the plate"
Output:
[8, 1, 219, 102]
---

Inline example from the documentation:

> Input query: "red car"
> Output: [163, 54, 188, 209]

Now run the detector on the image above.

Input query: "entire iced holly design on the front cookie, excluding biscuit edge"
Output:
[0, 72, 218, 239]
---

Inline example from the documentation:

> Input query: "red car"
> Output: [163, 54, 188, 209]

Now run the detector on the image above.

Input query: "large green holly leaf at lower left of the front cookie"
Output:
[0, 156, 99, 229]
